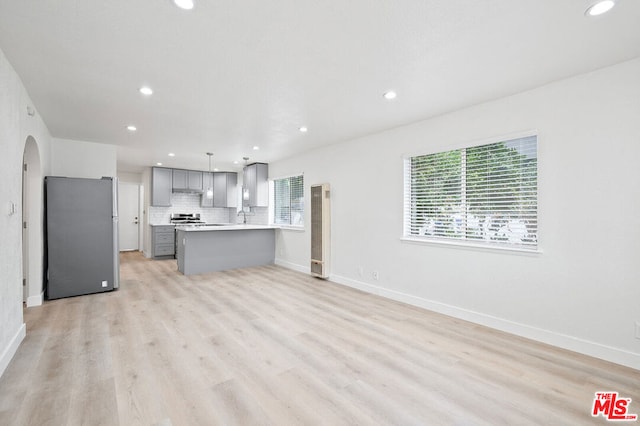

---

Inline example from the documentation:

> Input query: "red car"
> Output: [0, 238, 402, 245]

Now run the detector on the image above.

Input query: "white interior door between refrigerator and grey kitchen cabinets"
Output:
[118, 182, 140, 251]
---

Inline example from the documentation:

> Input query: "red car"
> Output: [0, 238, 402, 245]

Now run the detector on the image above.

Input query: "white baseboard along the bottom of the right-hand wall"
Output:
[276, 259, 640, 369]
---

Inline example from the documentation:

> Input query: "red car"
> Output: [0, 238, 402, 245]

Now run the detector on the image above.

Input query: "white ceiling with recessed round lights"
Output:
[0, 0, 640, 171]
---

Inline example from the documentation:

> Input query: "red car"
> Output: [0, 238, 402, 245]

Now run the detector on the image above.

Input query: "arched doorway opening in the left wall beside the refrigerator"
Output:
[22, 136, 44, 307]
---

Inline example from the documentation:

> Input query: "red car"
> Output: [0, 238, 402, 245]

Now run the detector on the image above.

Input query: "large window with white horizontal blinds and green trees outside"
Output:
[404, 136, 538, 250]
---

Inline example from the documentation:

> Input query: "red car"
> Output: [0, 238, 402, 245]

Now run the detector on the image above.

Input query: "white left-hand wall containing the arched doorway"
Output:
[0, 50, 51, 374]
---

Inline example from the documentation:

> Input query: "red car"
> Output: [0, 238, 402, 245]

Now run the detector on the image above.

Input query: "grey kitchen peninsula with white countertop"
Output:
[176, 225, 276, 275]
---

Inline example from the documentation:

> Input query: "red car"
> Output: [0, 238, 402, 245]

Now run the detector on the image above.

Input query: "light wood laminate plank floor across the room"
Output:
[0, 253, 640, 426]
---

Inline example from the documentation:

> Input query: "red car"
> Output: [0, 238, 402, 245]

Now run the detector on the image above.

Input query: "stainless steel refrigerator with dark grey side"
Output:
[44, 176, 120, 299]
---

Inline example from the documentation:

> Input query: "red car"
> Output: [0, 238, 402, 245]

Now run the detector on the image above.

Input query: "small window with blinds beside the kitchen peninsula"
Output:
[273, 175, 304, 227]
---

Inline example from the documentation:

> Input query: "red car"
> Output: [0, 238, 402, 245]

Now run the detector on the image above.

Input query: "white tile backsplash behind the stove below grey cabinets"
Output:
[149, 192, 269, 225]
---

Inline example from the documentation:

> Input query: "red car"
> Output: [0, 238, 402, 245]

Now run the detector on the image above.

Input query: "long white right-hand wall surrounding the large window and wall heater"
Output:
[269, 59, 640, 368]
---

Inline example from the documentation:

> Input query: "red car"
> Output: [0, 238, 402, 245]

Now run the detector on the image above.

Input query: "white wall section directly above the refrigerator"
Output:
[51, 138, 117, 179]
